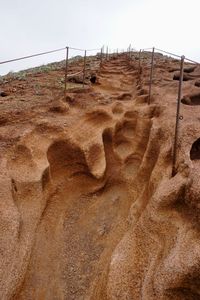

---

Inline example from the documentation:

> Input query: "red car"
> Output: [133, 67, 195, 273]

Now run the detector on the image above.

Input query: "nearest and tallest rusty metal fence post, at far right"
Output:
[172, 56, 185, 177]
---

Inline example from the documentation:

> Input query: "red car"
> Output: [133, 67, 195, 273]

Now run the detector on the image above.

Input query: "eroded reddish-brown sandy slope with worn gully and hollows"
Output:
[0, 55, 200, 300]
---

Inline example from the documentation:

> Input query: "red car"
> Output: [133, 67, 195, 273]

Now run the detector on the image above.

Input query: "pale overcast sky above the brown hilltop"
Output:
[0, 0, 200, 75]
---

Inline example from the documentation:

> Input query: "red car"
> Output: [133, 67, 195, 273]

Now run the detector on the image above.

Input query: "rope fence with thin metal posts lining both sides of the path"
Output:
[0, 45, 200, 176]
